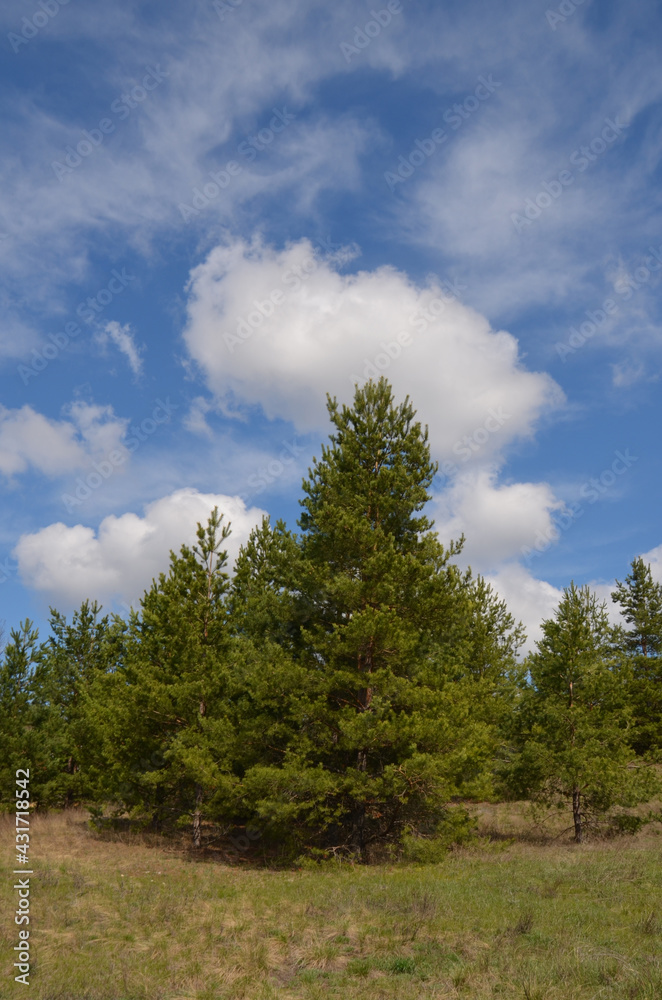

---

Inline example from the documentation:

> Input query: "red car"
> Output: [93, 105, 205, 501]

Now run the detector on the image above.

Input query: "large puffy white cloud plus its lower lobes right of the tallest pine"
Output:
[184, 240, 563, 629]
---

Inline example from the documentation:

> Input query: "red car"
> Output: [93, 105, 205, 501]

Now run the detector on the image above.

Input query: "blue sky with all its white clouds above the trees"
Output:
[0, 0, 662, 638]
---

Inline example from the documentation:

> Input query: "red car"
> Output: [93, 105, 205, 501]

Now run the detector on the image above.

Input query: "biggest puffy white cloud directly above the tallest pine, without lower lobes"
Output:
[184, 239, 563, 460]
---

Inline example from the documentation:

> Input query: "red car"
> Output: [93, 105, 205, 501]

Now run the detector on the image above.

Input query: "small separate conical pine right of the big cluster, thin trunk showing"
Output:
[504, 583, 655, 843]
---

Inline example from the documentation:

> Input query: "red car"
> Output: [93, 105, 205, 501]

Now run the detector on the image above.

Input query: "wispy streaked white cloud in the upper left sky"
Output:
[0, 0, 376, 304]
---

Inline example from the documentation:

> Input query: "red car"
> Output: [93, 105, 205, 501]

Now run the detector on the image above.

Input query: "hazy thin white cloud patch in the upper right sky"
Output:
[383, 5, 662, 324]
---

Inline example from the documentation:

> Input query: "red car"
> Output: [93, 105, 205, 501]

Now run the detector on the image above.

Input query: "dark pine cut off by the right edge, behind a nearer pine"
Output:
[611, 557, 662, 755]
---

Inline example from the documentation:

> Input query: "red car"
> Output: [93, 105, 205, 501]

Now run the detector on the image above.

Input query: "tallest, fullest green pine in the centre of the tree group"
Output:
[237, 379, 492, 856]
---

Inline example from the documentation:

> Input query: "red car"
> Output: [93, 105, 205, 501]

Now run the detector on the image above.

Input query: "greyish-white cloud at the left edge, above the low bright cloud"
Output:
[0, 402, 127, 477]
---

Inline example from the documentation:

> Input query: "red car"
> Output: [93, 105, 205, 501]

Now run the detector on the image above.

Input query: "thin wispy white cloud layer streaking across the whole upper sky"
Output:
[0, 0, 661, 336]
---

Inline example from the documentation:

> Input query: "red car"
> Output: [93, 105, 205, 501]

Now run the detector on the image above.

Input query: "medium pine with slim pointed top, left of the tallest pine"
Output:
[89, 508, 237, 848]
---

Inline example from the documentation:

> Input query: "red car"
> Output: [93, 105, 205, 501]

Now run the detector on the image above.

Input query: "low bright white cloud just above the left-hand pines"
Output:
[12, 489, 265, 610]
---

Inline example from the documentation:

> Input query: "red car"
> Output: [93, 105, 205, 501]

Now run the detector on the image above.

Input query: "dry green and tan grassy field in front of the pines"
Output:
[0, 806, 662, 1000]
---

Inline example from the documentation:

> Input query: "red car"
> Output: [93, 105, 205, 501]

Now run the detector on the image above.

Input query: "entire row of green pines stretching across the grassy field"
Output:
[0, 379, 662, 858]
